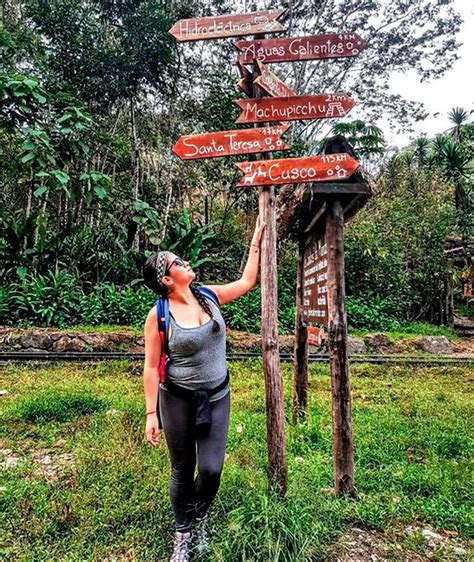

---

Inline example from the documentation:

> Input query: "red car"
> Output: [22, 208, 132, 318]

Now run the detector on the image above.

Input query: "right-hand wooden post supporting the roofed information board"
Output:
[326, 196, 354, 494]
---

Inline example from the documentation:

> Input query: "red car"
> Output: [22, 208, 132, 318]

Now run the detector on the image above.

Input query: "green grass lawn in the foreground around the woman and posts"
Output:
[0, 361, 474, 562]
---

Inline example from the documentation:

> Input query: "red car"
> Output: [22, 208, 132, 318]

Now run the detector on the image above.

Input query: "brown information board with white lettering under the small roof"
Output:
[303, 234, 329, 326]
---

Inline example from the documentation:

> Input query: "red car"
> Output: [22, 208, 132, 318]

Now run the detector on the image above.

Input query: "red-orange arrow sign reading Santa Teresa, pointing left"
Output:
[173, 123, 289, 160]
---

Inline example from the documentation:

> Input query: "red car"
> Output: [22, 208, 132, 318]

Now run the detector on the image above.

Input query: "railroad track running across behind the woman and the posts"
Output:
[0, 351, 474, 367]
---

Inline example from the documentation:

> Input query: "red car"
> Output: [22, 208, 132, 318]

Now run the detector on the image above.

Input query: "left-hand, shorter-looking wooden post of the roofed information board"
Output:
[293, 236, 308, 424]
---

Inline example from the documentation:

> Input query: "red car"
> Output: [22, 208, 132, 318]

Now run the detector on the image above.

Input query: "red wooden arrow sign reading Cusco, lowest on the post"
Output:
[236, 152, 359, 187]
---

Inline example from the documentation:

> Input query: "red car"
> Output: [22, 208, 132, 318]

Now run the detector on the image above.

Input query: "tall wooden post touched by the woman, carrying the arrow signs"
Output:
[252, 49, 288, 497]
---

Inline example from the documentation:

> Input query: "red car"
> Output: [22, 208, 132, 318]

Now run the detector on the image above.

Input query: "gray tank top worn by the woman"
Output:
[160, 299, 230, 402]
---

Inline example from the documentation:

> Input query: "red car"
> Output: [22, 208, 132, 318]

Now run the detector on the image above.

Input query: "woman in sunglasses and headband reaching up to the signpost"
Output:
[143, 220, 265, 562]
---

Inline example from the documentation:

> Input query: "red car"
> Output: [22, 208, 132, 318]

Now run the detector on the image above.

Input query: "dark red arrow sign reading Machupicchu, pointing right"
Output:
[235, 93, 354, 123]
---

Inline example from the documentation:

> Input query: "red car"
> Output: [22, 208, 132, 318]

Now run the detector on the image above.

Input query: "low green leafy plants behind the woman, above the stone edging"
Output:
[0, 253, 296, 333]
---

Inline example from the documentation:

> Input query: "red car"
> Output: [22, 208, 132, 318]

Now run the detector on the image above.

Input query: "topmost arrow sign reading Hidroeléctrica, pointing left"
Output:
[169, 10, 286, 41]
